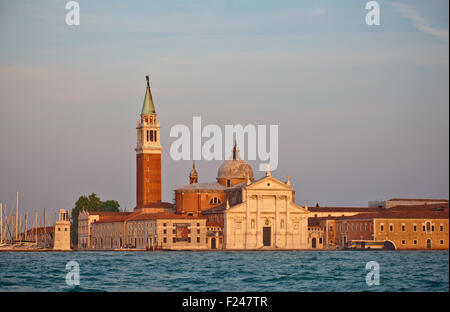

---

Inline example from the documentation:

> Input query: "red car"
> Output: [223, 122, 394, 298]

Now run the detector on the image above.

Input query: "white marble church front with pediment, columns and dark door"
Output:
[224, 175, 309, 249]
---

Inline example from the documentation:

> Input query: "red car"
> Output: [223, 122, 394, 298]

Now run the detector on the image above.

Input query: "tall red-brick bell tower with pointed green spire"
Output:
[135, 76, 162, 208]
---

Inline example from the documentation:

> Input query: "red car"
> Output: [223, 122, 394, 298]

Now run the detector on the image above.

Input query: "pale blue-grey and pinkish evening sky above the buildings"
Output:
[0, 0, 449, 223]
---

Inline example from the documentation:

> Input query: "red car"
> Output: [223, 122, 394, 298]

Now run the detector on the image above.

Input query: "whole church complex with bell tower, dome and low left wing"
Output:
[78, 76, 308, 250]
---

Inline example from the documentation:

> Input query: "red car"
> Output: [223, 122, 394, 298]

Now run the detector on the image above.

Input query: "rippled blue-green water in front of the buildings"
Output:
[0, 251, 449, 292]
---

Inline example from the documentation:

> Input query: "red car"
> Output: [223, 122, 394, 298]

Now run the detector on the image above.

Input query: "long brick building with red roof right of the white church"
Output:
[310, 202, 449, 250]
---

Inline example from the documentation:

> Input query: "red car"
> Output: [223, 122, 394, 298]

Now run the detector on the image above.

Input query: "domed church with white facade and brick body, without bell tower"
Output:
[175, 145, 309, 250]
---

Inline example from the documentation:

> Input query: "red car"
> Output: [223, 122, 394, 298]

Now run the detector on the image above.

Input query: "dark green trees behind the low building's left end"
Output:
[70, 193, 120, 246]
